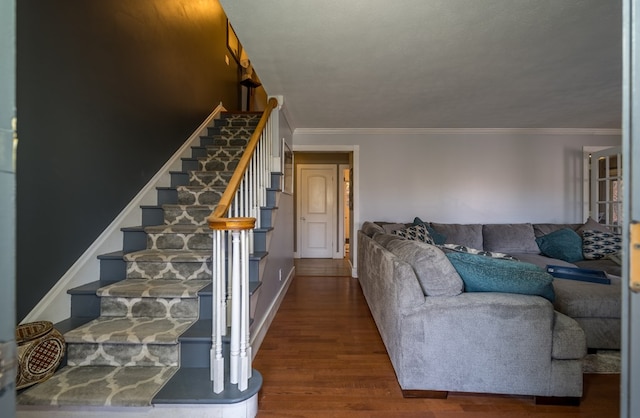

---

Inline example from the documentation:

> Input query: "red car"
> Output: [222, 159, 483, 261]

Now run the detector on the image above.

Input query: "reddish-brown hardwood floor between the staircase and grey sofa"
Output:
[254, 261, 620, 418]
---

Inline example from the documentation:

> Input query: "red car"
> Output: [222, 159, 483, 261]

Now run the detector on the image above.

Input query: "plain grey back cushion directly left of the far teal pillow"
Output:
[482, 223, 540, 254]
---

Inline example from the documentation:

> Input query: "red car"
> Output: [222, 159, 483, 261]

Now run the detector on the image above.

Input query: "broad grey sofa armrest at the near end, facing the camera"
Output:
[387, 293, 554, 396]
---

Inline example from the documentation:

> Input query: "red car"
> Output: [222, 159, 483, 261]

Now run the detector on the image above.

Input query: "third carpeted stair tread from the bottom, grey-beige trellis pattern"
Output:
[97, 279, 211, 299]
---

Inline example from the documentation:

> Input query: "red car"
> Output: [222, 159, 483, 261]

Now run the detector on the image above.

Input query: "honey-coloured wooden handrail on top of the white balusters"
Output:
[207, 97, 278, 230]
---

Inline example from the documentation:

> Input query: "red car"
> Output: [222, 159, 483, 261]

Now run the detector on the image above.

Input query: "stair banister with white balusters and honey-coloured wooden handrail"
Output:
[208, 99, 280, 393]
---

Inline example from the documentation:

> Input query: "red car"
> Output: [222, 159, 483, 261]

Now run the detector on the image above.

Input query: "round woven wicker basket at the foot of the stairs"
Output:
[16, 321, 65, 389]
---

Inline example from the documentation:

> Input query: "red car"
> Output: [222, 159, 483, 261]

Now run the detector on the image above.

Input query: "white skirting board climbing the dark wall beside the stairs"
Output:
[20, 103, 226, 323]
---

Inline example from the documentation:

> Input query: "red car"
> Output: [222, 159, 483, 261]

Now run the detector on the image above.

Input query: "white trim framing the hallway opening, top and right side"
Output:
[293, 145, 360, 277]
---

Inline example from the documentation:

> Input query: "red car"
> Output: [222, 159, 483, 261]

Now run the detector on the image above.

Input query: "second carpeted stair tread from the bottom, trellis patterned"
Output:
[64, 316, 195, 345]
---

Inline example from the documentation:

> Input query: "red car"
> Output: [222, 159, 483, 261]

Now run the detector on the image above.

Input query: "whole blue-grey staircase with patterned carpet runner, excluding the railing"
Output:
[17, 112, 279, 416]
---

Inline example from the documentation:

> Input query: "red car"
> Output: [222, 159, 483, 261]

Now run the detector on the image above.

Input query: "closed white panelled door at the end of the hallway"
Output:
[297, 164, 337, 258]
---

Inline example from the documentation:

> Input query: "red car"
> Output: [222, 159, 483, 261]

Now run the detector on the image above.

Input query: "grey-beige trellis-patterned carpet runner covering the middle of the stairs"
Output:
[18, 114, 260, 406]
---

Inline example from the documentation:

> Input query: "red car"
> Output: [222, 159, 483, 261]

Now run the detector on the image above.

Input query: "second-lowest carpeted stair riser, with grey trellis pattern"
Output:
[100, 296, 199, 319]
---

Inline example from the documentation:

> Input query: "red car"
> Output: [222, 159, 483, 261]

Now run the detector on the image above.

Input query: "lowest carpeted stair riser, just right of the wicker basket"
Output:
[67, 343, 179, 366]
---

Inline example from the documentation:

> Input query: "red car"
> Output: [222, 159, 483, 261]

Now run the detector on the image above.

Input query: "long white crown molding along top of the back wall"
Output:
[293, 128, 622, 136]
